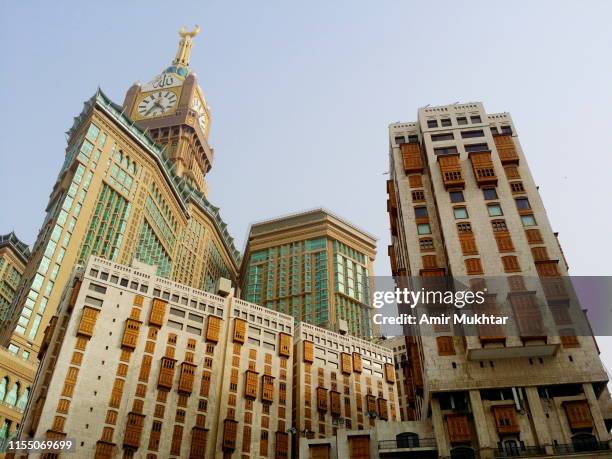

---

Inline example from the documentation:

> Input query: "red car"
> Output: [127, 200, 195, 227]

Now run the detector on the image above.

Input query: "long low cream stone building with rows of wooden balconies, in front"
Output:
[17, 257, 397, 459]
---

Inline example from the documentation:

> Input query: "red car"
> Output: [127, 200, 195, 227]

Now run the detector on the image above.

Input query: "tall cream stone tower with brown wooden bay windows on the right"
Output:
[387, 103, 612, 458]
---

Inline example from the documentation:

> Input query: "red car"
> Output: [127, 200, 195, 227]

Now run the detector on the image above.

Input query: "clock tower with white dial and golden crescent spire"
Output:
[123, 26, 214, 195]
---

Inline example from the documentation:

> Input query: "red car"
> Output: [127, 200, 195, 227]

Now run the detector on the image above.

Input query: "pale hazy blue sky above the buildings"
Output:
[0, 0, 612, 362]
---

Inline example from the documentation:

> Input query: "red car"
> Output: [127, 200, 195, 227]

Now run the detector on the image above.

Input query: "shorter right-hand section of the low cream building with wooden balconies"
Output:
[293, 322, 399, 446]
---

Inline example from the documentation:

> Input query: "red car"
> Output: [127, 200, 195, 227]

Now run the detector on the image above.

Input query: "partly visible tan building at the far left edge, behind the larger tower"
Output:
[0, 233, 30, 322]
